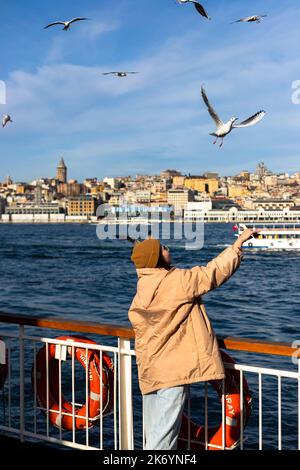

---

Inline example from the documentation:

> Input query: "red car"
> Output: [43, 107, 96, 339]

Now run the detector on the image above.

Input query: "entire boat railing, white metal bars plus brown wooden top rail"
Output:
[0, 312, 300, 450]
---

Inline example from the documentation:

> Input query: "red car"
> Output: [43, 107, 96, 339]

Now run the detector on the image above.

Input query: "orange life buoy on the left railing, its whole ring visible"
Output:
[32, 336, 114, 430]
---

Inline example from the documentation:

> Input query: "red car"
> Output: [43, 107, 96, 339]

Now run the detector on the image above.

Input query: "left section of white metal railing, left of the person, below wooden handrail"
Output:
[0, 325, 135, 450]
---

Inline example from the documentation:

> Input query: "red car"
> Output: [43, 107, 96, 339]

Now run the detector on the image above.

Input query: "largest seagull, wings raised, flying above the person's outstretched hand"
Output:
[201, 85, 266, 147]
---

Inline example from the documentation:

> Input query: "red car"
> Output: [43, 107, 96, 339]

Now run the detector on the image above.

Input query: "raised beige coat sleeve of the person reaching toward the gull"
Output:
[182, 246, 242, 299]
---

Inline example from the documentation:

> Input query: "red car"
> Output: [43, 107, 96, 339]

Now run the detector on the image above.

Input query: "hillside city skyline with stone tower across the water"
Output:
[0, 157, 300, 223]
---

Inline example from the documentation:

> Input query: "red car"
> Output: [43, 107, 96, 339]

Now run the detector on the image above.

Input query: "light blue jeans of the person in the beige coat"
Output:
[143, 385, 188, 450]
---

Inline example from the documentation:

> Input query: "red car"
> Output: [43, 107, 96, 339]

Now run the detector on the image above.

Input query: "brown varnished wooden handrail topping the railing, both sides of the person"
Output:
[0, 311, 295, 357]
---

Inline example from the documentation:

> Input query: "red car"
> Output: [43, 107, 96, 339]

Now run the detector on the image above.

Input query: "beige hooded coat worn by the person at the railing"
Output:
[129, 246, 241, 394]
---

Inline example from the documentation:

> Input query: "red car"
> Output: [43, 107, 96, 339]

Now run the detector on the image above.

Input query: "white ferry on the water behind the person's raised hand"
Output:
[233, 224, 300, 250]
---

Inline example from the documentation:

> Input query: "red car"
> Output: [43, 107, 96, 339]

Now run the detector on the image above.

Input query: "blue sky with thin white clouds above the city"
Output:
[0, 0, 300, 181]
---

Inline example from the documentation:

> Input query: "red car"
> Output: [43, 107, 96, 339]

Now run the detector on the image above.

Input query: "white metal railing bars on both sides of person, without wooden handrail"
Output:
[0, 325, 300, 450]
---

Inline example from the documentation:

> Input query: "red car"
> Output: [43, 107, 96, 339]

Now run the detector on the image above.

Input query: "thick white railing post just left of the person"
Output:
[118, 338, 134, 450]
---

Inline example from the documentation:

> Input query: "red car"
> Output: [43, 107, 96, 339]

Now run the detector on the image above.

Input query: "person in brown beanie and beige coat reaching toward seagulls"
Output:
[129, 229, 257, 450]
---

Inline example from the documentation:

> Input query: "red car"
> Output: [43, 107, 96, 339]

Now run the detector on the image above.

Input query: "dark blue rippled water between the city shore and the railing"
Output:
[0, 224, 300, 447]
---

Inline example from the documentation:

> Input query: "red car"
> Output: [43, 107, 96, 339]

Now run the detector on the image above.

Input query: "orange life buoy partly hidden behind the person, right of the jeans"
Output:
[178, 351, 252, 450]
